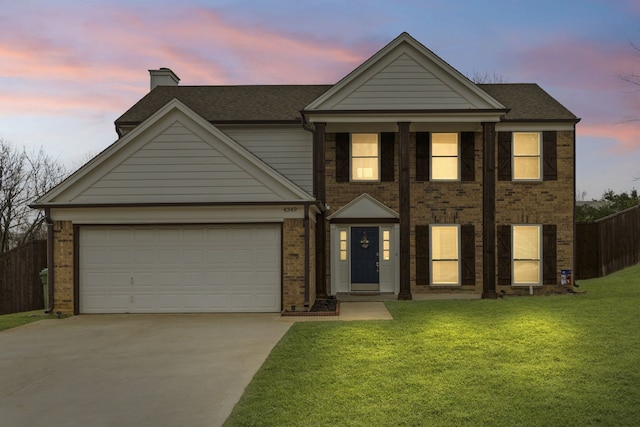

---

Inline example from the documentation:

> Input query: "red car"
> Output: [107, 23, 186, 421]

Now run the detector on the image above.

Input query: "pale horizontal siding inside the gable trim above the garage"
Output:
[72, 122, 298, 203]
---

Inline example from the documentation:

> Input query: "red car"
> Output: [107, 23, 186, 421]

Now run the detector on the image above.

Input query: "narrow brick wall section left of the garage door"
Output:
[52, 221, 74, 314]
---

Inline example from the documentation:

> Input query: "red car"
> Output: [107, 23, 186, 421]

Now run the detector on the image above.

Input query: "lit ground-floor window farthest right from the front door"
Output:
[511, 225, 542, 285]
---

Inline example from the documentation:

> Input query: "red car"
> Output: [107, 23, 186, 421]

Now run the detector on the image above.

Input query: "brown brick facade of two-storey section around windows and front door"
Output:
[325, 131, 575, 294]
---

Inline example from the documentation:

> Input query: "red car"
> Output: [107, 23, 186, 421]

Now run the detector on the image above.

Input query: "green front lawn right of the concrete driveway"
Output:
[225, 265, 640, 426]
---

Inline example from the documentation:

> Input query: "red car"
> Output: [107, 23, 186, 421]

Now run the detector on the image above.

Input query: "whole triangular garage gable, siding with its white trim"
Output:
[34, 99, 314, 208]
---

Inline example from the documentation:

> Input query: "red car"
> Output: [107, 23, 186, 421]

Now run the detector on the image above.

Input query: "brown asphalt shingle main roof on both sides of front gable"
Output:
[116, 83, 579, 126]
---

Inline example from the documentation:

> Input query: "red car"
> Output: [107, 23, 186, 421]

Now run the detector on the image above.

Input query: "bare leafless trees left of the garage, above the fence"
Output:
[0, 139, 67, 253]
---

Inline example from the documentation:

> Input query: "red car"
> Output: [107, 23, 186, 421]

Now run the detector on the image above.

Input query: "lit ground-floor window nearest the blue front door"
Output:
[430, 225, 460, 286]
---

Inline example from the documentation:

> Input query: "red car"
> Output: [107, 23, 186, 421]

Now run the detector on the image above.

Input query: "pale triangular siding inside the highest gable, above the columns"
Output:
[333, 53, 474, 110]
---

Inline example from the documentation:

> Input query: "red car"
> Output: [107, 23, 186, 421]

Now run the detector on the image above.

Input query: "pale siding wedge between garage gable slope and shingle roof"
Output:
[218, 125, 313, 193]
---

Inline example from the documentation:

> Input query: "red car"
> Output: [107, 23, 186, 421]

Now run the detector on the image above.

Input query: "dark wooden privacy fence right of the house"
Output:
[574, 205, 640, 279]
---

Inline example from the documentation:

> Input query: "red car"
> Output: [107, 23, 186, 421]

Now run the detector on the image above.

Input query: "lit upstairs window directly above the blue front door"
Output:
[351, 133, 380, 181]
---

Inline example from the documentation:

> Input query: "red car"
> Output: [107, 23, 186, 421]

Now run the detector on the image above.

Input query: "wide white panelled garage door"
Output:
[79, 224, 281, 313]
